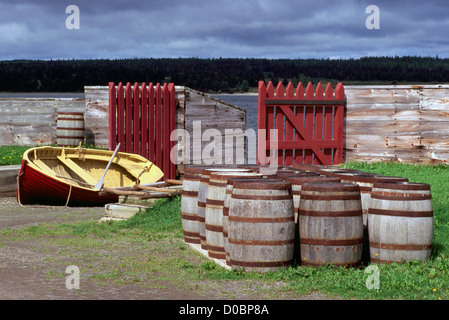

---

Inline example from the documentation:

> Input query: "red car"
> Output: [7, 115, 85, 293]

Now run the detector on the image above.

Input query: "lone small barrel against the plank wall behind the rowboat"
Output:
[56, 112, 86, 147]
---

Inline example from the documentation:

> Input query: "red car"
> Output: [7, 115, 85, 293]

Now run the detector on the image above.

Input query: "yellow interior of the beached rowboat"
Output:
[23, 147, 163, 189]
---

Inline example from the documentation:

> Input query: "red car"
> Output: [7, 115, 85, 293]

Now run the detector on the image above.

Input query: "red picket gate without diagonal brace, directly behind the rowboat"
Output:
[109, 82, 176, 179]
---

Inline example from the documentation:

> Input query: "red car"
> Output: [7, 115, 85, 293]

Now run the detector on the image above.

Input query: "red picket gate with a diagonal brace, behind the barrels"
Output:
[257, 81, 346, 166]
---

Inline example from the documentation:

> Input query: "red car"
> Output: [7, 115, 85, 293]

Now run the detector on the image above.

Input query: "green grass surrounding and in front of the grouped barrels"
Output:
[0, 162, 449, 300]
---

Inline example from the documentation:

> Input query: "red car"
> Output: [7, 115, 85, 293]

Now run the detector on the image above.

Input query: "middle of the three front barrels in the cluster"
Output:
[298, 183, 363, 267]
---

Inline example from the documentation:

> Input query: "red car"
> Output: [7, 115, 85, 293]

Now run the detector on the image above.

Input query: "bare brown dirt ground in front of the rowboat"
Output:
[0, 198, 327, 300]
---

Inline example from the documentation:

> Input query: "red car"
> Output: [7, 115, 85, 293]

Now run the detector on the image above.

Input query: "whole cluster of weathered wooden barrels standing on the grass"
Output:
[181, 165, 433, 272]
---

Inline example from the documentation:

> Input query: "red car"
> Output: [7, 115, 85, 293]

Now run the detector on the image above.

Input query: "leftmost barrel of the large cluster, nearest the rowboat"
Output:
[181, 166, 208, 244]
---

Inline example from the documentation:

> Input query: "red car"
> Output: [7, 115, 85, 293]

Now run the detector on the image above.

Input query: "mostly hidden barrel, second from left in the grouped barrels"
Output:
[198, 167, 251, 251]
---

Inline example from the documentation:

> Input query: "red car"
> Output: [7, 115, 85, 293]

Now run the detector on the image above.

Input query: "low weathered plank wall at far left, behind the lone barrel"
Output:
[0, 98, 85, 145]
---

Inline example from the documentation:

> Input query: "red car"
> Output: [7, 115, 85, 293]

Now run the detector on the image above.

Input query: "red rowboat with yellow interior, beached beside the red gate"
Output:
[17, 147, 164, 206]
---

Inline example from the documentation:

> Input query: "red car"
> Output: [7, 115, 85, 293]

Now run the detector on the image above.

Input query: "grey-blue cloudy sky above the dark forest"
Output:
[0, 0, 449, 60]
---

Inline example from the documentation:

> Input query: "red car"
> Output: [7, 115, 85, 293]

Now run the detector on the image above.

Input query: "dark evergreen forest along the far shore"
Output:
[0, 56, 449, 93]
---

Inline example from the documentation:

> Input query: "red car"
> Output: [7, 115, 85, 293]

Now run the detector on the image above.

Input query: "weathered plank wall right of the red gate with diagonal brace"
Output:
[344, 85, 449, 164]
